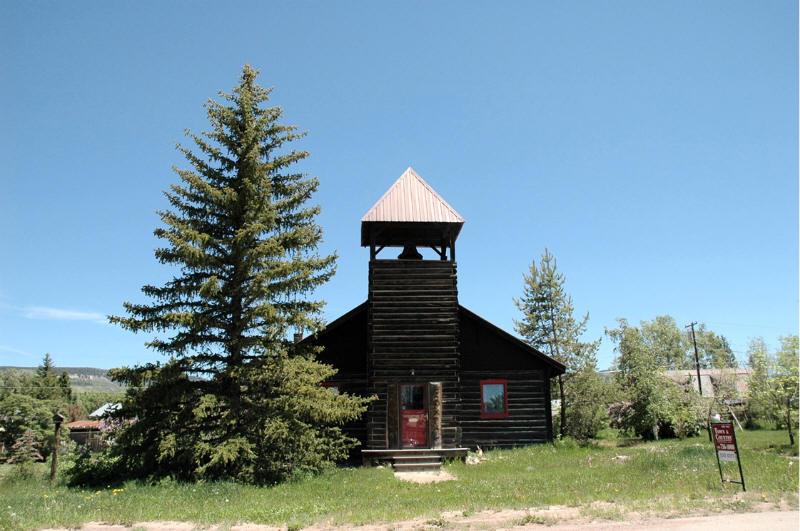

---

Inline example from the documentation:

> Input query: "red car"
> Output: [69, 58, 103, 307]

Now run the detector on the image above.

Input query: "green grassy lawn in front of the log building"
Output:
[0, 431, 798, 529]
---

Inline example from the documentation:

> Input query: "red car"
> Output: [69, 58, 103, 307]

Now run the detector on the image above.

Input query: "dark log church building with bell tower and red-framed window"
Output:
[304, 168, 565, 469]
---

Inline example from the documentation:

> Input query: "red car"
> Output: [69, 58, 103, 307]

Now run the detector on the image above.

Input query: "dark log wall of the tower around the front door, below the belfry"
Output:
[366, 259, 461, 449]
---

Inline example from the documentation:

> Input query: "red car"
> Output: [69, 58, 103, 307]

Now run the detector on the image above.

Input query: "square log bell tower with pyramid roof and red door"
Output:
[361, 168, 464, 449]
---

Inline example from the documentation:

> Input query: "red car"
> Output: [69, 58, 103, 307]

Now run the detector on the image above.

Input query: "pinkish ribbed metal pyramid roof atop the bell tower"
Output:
[361, 166, 464, 224]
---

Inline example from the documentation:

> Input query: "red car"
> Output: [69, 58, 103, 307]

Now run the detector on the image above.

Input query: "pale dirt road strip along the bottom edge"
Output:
[43, 507, 800, 531]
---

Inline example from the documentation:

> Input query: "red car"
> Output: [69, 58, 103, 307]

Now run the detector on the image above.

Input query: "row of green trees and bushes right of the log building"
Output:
[514, 249, 798, 444]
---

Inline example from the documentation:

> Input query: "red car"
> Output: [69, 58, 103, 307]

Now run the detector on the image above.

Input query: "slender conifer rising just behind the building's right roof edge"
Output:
[514, 248, 600, 437]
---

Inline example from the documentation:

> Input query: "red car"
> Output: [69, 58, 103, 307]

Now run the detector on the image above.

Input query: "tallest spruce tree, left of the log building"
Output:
[95, 65, 365, 483]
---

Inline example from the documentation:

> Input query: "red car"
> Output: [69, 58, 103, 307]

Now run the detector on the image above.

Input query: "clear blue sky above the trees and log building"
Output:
[0, 0, 798, 368]
